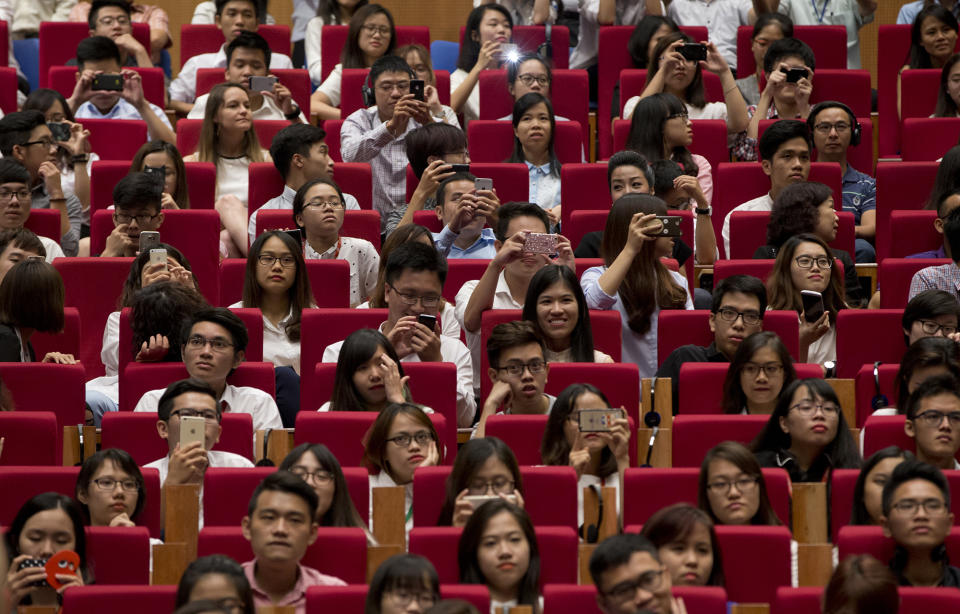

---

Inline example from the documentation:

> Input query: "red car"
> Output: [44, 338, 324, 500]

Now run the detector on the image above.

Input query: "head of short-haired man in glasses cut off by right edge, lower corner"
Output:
[903, 375, 960, 469]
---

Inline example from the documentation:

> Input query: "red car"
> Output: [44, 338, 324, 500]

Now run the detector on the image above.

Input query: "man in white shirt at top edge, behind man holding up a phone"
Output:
[169, 0, 293, 113]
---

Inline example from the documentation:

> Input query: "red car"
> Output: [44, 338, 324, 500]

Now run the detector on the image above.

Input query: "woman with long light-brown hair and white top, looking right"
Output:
[184, 83, 271, 258]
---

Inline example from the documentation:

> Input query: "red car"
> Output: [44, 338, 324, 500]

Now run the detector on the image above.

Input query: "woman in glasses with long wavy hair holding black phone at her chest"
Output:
[767, 234, 847, 364]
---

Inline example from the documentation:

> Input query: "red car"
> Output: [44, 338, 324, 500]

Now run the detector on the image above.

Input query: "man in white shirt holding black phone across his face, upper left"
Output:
[67, 36, 177, 145]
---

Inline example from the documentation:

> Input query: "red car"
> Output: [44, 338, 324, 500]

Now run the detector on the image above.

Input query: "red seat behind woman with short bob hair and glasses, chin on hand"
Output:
[294, 411, 457, 467]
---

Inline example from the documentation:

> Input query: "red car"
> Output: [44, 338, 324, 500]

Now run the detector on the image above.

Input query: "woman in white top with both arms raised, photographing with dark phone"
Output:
[623, 32, 750, 140]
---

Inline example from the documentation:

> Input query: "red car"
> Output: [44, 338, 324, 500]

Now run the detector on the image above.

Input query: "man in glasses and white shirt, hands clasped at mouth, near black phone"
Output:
[323, 242, 476, 427]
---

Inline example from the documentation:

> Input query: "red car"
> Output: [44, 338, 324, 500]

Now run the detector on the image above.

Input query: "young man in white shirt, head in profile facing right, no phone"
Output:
[247, 124, 360, 245]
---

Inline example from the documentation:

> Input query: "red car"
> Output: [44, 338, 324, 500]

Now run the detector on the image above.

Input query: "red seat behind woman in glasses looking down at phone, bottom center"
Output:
[413, 466, 578, 528]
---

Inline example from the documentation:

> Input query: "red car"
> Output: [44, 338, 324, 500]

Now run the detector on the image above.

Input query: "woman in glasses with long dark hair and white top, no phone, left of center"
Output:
[230, 230, 314, 373]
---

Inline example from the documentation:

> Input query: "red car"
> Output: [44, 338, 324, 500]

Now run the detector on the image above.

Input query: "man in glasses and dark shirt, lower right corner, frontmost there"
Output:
[880, 460, 960, 588]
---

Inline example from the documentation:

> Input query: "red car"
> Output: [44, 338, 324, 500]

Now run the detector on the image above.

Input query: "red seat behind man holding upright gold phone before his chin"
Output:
[100, 411, 254, 465]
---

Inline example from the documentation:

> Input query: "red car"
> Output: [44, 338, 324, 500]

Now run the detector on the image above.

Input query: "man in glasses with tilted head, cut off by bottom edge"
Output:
[590, 533, 687, 614]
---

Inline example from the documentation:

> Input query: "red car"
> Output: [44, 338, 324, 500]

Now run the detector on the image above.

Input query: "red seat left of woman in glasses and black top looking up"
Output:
[672, 415, 770, 467]
